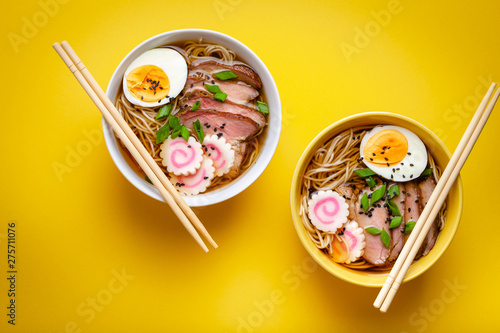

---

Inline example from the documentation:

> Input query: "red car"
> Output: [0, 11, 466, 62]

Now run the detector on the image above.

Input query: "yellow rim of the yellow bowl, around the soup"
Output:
[290, 111, 463, 287]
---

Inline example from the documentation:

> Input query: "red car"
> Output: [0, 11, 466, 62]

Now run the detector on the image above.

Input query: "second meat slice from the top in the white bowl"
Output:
[184, 77, 259, 105]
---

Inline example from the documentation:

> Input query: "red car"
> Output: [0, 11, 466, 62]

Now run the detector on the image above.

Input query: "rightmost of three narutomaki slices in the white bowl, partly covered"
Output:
[203, 135, 234, 177]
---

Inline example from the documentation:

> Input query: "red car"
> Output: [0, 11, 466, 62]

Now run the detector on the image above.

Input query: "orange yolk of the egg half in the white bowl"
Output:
[127, 65, 170, 103]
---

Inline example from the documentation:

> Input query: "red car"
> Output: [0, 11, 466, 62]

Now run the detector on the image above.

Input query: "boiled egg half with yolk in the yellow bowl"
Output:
[360, 125, 427, 182]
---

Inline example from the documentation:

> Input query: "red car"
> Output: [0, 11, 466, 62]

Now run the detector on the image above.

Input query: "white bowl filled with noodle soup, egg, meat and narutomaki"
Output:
[104, 29, 281, 206]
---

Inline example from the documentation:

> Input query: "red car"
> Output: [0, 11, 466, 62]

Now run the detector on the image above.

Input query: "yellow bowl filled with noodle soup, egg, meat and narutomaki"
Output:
[291, 112, 461, 286]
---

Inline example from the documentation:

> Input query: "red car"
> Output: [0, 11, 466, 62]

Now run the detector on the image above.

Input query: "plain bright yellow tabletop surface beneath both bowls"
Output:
[0, 0, 500, 332]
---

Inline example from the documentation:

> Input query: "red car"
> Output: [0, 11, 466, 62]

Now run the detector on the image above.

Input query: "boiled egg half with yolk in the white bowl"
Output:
[123, 48, 187, 107]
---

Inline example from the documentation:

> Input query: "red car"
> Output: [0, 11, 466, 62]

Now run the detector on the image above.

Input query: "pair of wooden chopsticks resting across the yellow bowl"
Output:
[373, 83, 500, 312]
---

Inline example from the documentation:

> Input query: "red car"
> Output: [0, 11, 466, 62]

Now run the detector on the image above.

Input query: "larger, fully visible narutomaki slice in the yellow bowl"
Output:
[308, 190, 349, 232]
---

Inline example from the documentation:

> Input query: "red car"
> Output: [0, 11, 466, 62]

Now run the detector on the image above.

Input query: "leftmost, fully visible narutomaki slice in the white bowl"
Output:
[160, 137, 203, 176]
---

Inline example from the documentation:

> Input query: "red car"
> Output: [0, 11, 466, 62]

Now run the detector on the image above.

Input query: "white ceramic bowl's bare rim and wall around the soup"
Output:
[103, 29, 281, 207]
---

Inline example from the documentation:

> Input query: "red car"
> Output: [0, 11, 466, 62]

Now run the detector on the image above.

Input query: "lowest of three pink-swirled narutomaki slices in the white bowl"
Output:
[170, 157, 215, 195]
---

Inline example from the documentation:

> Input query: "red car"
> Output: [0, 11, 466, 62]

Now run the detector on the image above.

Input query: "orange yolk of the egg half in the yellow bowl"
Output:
[363, 129, 408, 166]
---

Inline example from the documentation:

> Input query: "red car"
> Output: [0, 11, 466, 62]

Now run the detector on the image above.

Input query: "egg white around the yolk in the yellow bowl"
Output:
[360, 125, 427, 182]
